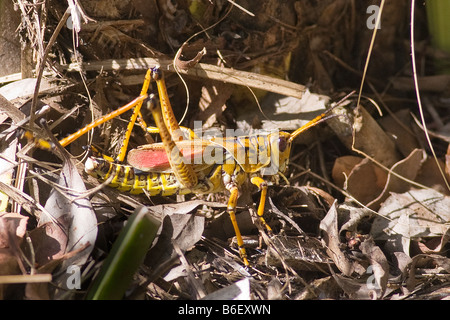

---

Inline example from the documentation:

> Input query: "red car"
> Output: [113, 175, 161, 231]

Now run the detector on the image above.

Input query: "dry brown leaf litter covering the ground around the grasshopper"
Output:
[0, 0, 450, 300]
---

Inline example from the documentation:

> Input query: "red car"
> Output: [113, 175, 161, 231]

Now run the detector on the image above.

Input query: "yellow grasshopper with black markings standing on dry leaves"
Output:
[27, 67, 344, 266]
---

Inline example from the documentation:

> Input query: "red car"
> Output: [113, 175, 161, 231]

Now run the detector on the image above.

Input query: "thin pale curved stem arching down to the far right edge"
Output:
[410, 0, 450, 190]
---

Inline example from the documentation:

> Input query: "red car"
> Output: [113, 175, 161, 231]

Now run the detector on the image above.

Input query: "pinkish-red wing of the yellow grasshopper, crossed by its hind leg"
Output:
[127, 140, 212, 171]
